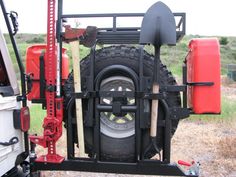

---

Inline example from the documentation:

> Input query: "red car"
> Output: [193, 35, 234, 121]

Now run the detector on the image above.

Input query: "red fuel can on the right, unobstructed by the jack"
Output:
[186, 38, 221, 114]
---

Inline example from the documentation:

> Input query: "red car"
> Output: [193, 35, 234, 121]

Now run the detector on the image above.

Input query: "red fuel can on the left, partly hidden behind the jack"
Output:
[26, 44, 69, 100]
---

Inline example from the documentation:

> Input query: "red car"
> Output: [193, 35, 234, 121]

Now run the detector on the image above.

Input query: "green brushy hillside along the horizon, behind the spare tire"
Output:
[5, 34, 236, 76]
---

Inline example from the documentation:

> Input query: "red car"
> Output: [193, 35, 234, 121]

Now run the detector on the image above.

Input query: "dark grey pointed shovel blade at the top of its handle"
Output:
[139, 1, 176, 47]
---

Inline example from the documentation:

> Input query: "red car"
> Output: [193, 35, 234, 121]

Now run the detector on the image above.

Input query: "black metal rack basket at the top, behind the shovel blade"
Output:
[61, 13, 186, 44]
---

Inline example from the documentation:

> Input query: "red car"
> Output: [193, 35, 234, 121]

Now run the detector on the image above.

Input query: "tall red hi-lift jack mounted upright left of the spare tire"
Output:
[30, 0, 64, 163]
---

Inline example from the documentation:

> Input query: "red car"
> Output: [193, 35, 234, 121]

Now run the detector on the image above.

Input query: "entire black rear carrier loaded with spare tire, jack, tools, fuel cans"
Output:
[1, 0, 220, 177]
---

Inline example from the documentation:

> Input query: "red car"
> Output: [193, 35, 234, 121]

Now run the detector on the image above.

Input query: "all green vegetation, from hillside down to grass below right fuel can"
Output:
[5, 34, 236, 133]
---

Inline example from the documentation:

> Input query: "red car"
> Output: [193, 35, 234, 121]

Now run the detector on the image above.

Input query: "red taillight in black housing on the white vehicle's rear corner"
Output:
[13, 107, 30, 132]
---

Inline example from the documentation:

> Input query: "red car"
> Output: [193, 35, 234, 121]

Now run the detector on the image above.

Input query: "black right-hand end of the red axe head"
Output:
[80, 26, 97, 47]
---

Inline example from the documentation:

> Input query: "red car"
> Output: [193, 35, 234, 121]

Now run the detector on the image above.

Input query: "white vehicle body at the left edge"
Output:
[0, 30, 24, 176]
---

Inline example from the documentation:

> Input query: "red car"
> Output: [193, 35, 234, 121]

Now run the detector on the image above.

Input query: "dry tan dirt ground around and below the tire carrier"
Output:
[38, 81, 236, 177]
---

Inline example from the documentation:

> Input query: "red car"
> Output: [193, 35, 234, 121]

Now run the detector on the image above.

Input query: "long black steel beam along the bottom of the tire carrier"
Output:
[32, 158, 197, 177]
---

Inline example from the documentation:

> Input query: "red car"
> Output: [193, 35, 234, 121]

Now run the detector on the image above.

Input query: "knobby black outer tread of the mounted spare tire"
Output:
[64, 45, 181, 161]
